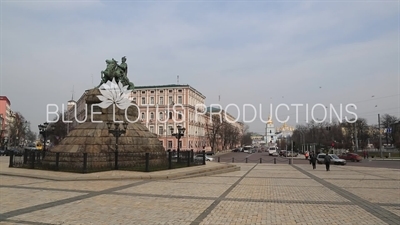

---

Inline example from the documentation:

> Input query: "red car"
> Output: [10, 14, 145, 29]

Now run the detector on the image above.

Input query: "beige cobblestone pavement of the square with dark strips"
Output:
[0, 163, 400, 225]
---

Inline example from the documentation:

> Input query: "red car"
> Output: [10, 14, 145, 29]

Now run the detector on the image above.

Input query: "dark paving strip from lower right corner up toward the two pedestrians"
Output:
[292, 165, 400, 225]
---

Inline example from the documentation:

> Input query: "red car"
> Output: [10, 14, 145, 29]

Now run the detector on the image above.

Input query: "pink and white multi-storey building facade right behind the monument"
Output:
[130, 84, 207, 151]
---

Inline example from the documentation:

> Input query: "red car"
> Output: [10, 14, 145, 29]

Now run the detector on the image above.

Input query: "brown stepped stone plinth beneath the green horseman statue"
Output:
[43, 88, 165, 169]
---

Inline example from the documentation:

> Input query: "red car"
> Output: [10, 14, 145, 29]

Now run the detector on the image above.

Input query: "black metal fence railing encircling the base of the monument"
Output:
[9, 150, 206, 173]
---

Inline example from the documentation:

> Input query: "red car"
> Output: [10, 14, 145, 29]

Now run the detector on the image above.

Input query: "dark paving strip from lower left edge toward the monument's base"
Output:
[0, 180, 151, 222]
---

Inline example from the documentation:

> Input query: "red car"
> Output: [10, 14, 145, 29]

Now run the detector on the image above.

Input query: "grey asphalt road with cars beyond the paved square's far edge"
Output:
[216, 152, 400, 169]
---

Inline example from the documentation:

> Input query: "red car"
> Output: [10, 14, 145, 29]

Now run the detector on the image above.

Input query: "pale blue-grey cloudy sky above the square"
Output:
[0, 0, 400, 133]
